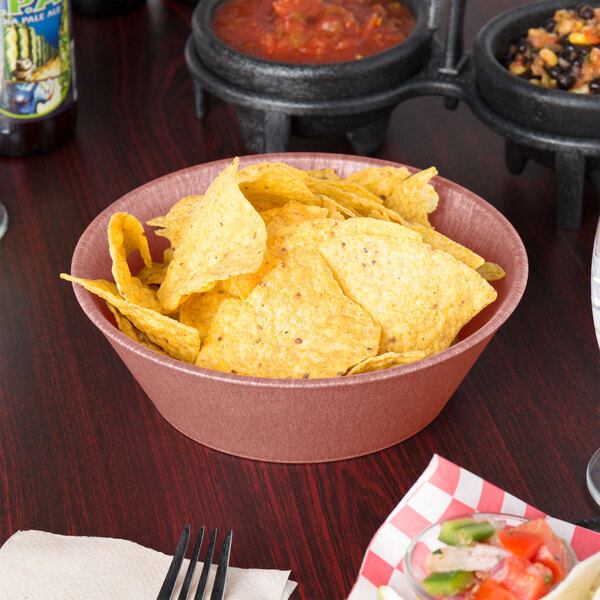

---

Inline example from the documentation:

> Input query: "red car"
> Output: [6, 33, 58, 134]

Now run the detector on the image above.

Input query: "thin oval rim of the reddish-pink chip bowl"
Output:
[71, 152, 529, 390]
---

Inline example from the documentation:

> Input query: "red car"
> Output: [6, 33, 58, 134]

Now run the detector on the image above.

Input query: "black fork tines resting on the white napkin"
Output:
[156, 525, 233, 600]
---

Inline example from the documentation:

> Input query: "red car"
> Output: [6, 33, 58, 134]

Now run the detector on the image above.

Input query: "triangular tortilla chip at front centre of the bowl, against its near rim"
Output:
[196, 249, 381, 378]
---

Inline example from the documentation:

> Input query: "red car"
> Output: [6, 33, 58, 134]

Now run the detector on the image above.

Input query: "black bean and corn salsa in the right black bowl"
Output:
[505, 4, 600, 94]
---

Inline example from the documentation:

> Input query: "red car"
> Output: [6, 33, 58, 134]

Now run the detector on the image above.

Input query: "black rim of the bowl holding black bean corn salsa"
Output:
[473, 0, 600, 110]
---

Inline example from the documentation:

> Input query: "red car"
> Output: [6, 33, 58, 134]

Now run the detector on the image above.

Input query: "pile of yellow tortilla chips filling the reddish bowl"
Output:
[61, 158, 504, 378]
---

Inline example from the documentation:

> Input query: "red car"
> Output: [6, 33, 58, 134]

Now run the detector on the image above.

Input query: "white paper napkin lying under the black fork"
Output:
[0, 531, 296, 600]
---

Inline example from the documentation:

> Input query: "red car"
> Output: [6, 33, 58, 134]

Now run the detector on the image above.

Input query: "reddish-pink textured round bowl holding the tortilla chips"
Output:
[71, 153, 528, 463]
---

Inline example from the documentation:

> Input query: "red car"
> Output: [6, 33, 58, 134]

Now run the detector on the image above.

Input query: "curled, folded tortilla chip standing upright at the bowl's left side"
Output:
[108, 212, 160, 311]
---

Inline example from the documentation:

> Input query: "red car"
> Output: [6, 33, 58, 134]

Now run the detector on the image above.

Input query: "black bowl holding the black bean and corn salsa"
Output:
[473, 0, 600, 138]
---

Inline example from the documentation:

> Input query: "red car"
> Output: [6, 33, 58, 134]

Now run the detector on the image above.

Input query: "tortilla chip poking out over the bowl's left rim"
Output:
[60, 273, 200, 363]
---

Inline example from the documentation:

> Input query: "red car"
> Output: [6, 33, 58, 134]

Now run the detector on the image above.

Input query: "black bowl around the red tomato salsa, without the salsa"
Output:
[192, 0, 432, 102]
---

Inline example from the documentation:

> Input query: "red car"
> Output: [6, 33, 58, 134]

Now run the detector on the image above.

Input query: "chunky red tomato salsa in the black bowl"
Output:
[213, 0, 415, 64]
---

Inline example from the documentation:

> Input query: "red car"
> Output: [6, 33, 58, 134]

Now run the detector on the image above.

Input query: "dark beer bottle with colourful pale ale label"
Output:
[0, 0, 77, 156]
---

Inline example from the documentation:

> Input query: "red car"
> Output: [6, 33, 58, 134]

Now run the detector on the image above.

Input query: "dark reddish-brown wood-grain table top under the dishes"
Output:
[0, 0, 600, 600]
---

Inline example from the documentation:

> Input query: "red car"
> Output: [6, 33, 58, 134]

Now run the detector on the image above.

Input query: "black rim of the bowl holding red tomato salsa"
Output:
[192, 0, 432, 72]
